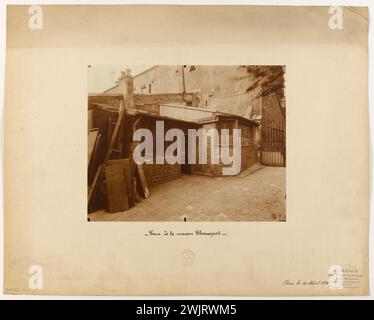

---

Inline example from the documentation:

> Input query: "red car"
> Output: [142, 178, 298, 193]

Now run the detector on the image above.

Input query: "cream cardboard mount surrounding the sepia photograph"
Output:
[4, 5, 369, 296]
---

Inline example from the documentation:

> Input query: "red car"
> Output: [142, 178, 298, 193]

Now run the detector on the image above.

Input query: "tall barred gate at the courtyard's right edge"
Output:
[261, 118, 286, 167]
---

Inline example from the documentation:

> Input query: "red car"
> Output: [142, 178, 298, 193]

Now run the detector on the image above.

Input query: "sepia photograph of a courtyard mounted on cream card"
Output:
[87, 65, 286, 222]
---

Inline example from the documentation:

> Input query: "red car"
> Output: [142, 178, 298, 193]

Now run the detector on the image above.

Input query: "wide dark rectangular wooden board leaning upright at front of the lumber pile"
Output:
[105, 162, 129, 213]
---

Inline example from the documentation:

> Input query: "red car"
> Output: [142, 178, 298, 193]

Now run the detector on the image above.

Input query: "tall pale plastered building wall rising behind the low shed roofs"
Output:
[104, 65, 266, 118]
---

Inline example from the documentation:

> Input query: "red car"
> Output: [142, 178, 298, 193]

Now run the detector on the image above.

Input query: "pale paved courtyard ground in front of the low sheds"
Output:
[89, 167, 286, 222]
